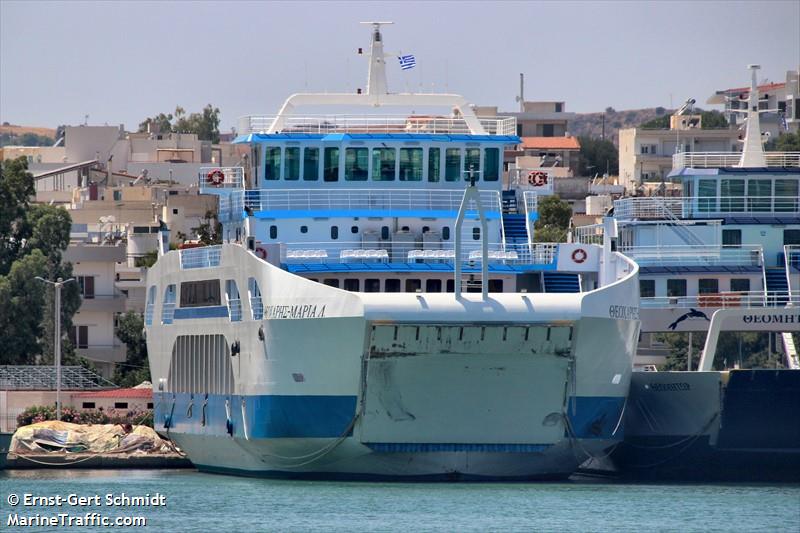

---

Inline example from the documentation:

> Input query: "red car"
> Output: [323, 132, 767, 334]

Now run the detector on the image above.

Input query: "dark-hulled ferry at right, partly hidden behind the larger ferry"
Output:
[575, 65, 800, 481]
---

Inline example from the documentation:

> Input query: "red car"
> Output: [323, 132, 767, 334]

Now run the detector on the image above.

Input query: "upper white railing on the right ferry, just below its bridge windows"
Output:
[614, 191, 800, 220]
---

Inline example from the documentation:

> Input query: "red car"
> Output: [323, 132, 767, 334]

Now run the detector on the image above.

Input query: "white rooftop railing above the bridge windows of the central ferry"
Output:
[239, 115, 517, 135]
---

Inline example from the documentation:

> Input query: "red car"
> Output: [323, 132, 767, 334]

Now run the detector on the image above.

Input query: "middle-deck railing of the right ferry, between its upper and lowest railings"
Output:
[617, 245, 763, 268]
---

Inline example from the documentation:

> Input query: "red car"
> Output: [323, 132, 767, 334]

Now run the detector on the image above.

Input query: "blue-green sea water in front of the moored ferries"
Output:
[0, 470, 800, 532]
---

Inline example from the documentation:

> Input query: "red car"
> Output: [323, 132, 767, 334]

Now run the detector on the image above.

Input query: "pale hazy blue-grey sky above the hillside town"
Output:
[0, 0, 800, 131]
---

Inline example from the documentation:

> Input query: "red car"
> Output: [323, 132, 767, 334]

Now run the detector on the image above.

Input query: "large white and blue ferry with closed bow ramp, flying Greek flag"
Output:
[145, 23, 639, 480]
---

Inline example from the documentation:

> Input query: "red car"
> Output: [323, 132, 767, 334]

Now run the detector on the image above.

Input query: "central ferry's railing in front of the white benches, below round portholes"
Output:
[281, 241, 558, 265]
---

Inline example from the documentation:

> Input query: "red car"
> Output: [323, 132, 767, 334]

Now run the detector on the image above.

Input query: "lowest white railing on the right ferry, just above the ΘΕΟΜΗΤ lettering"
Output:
[640, 291, 800, 309]
